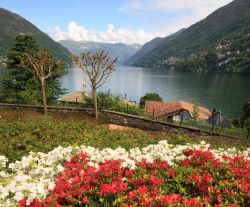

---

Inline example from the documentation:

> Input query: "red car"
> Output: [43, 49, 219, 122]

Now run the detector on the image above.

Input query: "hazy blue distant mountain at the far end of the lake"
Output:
[59, 40, 141, 64]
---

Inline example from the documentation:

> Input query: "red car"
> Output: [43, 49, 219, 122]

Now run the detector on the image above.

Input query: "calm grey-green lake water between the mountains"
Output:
[61, 66, 250, 118]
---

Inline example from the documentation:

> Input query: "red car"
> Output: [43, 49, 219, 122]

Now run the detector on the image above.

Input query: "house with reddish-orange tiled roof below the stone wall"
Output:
[145, 100, 212, 121]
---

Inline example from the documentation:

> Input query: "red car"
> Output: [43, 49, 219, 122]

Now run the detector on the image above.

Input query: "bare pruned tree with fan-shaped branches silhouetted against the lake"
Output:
[74, 50, 117, 120]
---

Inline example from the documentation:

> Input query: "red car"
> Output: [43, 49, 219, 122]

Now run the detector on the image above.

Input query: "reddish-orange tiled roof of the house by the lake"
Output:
[145, 101, 212, 120]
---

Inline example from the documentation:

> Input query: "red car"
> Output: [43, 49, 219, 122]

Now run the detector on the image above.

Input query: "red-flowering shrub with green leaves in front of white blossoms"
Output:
[19, 149, 250, 207]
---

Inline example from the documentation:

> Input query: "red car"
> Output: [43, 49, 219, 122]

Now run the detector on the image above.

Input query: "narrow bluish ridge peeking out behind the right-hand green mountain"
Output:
[125, 29, 185, 65]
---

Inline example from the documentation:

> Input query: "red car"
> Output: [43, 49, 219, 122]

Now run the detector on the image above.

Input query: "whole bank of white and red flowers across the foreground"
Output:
[0, 140, 250, 207]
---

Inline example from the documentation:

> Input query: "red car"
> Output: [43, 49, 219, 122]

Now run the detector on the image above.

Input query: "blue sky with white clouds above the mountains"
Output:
[0, 0, 232, 44]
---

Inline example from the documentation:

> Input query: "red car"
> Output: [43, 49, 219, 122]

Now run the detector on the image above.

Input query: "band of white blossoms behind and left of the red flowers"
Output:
[0, 140, 250, 207]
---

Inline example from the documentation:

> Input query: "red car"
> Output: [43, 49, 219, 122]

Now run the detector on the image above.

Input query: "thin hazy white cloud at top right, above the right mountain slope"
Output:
[121, 0, 233, 36]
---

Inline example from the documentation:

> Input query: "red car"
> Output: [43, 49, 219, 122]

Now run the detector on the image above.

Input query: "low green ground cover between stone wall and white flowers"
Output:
[0, 112, 162, 161]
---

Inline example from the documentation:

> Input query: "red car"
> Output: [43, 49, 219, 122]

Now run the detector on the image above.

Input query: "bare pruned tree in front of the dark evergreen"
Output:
[20, 50, 61, 115]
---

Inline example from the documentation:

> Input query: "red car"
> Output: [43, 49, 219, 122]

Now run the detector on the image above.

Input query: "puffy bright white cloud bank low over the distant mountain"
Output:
[48, 21, 159, 44]
